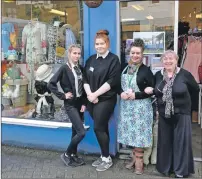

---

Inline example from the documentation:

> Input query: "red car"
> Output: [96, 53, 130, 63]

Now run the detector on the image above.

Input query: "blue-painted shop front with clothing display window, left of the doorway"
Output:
[1, 0, 118, 155]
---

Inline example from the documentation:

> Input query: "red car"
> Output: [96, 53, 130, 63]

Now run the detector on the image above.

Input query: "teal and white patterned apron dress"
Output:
[118, 66, 153, 148]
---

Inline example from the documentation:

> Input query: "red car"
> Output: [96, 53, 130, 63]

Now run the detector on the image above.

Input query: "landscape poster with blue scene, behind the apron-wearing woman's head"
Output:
[133, 32, 165, 54]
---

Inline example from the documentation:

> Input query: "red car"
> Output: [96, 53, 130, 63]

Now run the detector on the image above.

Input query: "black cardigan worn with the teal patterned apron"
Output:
[119, 64, 154, 99]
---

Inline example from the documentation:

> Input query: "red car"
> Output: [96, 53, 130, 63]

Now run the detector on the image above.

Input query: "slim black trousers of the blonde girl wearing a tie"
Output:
[64, 98, 85, 155]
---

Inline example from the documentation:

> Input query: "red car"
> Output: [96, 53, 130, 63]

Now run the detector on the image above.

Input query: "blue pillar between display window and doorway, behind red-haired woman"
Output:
[84, 1, 119, 155]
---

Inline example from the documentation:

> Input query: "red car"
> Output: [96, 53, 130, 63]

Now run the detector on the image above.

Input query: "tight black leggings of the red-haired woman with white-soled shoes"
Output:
[88, 96, 117, 157]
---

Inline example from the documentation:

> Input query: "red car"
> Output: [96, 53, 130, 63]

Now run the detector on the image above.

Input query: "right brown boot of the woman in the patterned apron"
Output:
[135, 148, 144, 175]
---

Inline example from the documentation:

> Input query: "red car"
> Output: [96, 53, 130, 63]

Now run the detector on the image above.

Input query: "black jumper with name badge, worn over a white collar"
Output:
[84, 52, 121, 101]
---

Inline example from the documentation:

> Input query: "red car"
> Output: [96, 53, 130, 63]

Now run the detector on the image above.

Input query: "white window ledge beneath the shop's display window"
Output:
[1, 117, 90, 130]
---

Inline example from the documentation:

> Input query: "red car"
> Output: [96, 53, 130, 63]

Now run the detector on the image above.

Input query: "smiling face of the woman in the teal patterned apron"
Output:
[130, 46, 143, 64]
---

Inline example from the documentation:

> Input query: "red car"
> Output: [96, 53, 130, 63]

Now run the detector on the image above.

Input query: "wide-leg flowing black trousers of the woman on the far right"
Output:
[156, 114, 194, 176]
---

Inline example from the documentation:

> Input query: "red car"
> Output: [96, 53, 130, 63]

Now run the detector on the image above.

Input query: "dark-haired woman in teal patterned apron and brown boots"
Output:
[118, 39, 154, 174]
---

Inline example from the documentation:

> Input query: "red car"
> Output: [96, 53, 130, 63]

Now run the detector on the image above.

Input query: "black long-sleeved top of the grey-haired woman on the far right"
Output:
[154, 69, 199, 116]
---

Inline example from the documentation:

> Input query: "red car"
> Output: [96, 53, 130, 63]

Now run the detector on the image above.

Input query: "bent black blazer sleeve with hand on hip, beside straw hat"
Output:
[48, 67, 66, 100]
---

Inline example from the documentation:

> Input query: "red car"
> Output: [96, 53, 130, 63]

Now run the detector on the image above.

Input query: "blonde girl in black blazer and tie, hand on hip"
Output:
[48, 44, 86, 167]
